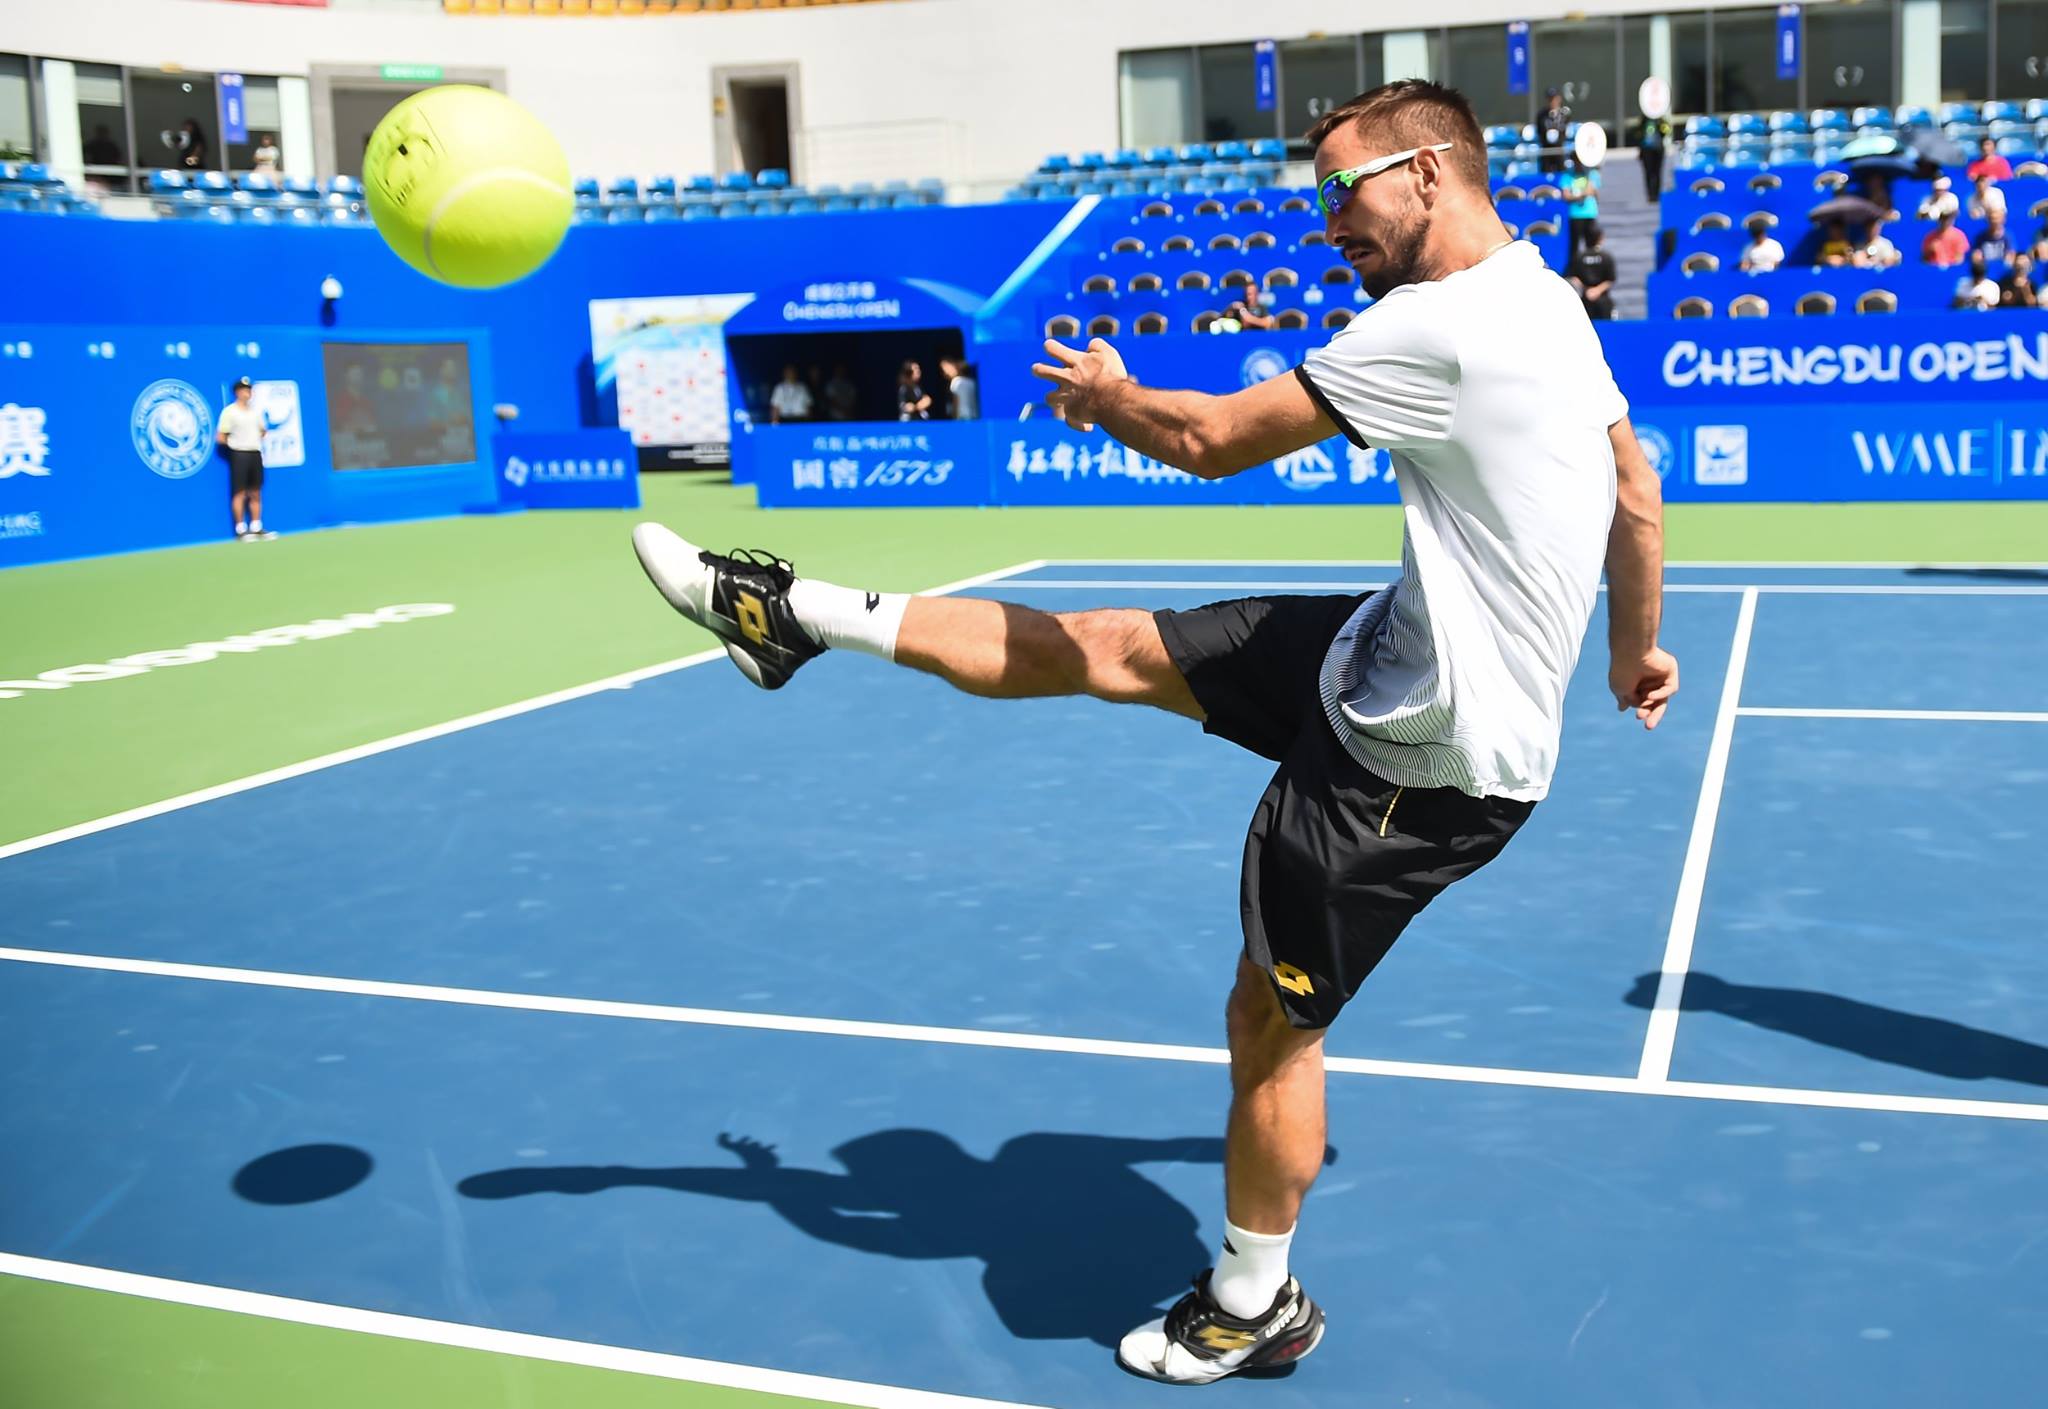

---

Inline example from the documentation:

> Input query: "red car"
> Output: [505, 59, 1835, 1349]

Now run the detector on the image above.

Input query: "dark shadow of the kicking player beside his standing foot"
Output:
[457, 1130, 1335, 1346]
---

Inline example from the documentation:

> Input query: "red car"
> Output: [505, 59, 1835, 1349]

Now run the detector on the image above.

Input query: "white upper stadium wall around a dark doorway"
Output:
[0, 0, 1728, 186]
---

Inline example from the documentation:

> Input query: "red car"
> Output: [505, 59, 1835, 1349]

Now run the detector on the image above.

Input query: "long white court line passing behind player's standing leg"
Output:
[0, 948, 2048, 1120]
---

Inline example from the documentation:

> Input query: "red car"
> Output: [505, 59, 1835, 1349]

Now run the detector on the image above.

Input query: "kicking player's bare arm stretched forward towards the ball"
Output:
[1032, 338, 1337, 479]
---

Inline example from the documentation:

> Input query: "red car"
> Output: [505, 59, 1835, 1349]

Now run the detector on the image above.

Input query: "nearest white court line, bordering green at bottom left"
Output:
[0, 1253, 1056, 1409]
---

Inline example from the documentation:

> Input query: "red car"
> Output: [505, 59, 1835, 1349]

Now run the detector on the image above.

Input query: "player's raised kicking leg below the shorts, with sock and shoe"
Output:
[633, 524, 1202, 719]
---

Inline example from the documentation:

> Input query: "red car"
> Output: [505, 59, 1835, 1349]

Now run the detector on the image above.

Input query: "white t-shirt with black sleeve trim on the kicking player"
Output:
[1298, 242, 1628, 801]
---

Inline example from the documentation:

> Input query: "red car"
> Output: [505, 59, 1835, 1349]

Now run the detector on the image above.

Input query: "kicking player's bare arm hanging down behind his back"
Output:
[1608, 416, 1677, 729]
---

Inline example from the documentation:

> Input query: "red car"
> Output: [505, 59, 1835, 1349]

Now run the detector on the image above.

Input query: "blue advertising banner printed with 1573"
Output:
[733, 420, 991, 508]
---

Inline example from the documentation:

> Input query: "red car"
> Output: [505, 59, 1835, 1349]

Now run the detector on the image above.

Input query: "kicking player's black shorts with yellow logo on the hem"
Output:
[1153, 596, 1536, 1028]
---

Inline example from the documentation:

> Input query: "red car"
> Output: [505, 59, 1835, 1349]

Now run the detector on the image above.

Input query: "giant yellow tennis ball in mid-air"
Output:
[362, 84, 575, 289]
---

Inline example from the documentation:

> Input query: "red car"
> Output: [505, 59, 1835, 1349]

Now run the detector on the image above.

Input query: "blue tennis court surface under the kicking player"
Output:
[0, 561, 2048, 1409]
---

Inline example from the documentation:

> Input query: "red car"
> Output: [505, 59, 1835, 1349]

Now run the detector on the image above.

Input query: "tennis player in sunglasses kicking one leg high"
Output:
[633, 80, 1677, 1382]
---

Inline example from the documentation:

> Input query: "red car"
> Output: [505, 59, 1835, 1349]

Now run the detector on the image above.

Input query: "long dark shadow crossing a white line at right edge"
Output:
[1626, 973, 2048, 1085]
